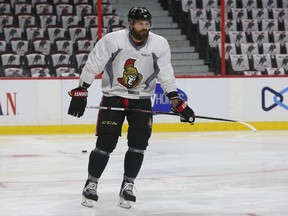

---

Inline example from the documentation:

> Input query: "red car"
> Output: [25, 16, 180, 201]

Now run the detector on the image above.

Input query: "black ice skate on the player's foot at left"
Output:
[81, 180, 98, 208]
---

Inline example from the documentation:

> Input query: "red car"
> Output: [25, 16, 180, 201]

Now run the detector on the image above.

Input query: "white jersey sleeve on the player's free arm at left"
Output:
[80, 37, 113, 84]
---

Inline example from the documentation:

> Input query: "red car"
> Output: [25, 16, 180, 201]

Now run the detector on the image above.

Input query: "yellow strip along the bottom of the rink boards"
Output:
[0, 122, 288, 135]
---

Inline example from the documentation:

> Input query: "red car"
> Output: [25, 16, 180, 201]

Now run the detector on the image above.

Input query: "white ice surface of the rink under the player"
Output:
[0, 131, 288, 216]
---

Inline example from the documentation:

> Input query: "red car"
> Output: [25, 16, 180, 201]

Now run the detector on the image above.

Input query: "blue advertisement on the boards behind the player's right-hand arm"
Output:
[152, 83, 187, 112]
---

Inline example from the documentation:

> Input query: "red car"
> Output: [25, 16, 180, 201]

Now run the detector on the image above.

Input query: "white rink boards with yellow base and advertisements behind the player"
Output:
[0, 77, 288, 134]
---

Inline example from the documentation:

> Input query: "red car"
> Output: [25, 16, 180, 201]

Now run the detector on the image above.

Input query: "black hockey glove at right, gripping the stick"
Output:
[171, 98, 195, 125]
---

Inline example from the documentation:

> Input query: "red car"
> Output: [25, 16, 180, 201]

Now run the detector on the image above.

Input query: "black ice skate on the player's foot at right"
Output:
[118, 181, 136, 209]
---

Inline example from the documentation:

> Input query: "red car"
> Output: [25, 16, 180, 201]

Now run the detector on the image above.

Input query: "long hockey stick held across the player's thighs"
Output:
[86, 106, 257, 132]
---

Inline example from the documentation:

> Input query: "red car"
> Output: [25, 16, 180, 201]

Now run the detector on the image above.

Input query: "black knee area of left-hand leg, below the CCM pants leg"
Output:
[96, 134, 119, 153]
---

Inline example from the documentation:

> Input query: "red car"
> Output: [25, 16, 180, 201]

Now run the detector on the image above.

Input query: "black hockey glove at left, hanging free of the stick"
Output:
[68, 87, 88, 118]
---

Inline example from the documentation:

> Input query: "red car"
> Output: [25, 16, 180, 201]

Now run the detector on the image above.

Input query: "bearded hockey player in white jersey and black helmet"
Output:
[68, 7, 194, 208]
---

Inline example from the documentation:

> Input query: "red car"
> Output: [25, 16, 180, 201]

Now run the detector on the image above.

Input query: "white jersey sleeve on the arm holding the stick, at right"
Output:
[157, 38, 177, 94]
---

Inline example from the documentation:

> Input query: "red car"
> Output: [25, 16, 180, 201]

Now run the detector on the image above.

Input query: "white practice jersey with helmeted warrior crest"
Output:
[80, 29, 177, 99]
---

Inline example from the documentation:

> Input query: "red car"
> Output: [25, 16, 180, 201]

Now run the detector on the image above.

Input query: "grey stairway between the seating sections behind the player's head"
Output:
[110, 0, 213, 76]
